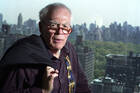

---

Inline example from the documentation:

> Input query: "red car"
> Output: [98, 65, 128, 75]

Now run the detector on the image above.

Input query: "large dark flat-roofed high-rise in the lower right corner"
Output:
[105, 53, 140, 93]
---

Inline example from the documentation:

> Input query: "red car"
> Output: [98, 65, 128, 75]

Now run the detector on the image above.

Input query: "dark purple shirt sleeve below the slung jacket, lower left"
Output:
[0, 67, 42, 93]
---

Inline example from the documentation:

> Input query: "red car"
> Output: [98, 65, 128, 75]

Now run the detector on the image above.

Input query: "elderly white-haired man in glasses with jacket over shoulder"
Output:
[0, 3, 90, 93]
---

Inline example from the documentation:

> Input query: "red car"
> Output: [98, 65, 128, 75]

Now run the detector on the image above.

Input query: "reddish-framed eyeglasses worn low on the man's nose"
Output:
[42, 21, 72, 34]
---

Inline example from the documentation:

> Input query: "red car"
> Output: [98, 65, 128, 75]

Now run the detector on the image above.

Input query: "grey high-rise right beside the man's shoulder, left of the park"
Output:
[75, 36, 94, 84]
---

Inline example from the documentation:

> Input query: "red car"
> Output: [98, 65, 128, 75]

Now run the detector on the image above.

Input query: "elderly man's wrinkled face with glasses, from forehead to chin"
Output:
[41, 8, 71, 50]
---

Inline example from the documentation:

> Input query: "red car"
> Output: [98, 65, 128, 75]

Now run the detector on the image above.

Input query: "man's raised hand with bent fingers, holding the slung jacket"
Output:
[42, 66, 58, 93]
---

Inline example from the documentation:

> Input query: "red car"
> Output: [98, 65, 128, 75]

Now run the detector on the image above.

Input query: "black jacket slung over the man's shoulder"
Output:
[0, 35, 56, 68]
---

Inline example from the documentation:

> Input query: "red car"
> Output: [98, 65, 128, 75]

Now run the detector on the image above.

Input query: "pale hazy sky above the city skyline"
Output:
[0, 0, 140, 26]
